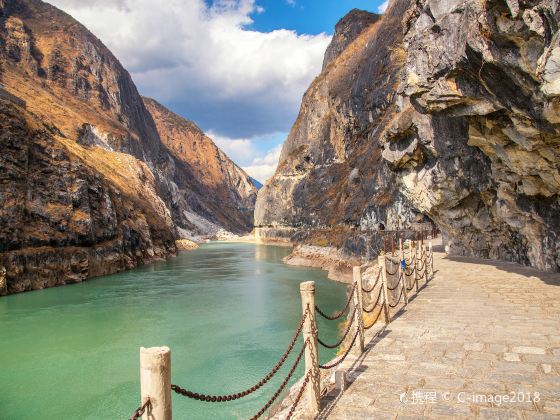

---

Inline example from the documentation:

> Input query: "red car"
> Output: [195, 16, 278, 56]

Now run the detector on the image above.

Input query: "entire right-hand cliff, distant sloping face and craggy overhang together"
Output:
[255, 0, 560, 271]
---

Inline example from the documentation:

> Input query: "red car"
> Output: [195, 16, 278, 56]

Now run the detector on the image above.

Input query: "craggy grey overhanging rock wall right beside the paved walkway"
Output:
[390, 1, 560, 271]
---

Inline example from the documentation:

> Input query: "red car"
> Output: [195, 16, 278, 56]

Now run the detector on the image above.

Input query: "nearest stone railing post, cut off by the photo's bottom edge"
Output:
[140, 347, 171, 420]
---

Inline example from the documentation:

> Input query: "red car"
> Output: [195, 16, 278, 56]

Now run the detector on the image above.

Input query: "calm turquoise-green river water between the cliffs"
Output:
[0, 243, 346, 420]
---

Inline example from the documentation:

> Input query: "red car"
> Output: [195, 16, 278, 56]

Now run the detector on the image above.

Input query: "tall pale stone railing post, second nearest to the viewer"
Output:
[299, 281, 321, 416]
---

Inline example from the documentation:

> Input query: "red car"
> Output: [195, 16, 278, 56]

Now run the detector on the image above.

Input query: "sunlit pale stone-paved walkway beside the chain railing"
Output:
[320, 253, 560, 419]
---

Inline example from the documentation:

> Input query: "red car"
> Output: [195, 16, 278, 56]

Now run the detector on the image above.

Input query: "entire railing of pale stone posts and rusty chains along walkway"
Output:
[130, 240, 434, 420]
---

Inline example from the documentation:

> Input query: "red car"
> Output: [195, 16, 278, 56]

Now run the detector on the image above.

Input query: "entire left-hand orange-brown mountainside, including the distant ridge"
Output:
[0, 0, 256, 293]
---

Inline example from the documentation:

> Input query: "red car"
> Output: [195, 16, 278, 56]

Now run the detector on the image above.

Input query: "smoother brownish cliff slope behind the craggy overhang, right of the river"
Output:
[255, 1, 424, 233]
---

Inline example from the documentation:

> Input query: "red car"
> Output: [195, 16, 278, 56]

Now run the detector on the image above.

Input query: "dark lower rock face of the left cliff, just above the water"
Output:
[0, 100, 175, 295]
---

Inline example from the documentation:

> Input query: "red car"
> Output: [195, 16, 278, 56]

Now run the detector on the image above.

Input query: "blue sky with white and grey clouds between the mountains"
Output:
[48, 0, 383, 181]
